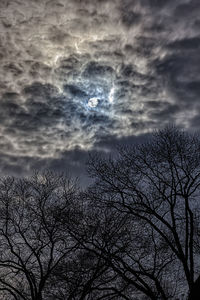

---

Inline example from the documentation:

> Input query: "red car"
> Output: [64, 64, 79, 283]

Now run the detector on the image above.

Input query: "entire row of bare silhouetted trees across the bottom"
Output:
[0, 127, 200, 300]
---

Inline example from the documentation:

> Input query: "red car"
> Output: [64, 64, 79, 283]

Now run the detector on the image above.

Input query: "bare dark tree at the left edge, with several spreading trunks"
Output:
[0, 172, 77, 300]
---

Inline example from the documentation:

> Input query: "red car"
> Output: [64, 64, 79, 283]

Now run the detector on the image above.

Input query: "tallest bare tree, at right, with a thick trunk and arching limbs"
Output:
[88, 127, 200, 300]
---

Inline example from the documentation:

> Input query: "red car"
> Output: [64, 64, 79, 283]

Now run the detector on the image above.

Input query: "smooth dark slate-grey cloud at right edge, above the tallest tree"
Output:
[155, 44, 200, 109]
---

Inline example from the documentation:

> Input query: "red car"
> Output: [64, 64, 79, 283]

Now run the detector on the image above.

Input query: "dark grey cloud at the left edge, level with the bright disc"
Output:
[0, 82, 67, 132]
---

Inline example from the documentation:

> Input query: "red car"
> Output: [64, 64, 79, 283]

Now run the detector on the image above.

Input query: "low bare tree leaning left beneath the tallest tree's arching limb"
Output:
[72, 186, 179, 299]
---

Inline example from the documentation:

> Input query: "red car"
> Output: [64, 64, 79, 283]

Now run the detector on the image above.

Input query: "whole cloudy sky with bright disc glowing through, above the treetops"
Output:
[0, 0, 200, 180]
